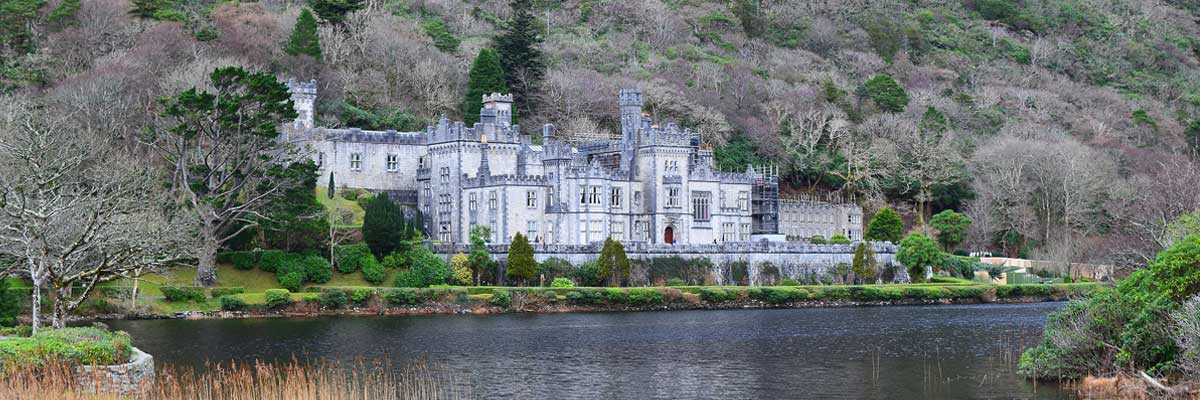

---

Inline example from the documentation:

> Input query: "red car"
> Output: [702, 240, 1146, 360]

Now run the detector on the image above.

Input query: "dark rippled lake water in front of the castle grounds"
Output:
[109, 303, 1069, 399]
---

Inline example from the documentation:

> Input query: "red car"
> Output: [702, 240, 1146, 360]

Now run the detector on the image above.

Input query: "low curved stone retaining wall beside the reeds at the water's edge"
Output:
[74, 347, 155, 396]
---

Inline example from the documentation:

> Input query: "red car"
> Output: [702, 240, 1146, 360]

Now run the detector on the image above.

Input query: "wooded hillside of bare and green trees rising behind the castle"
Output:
[0, 0, 1200, 267]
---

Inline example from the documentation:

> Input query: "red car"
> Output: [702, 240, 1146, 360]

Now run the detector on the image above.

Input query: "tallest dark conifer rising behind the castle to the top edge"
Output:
[496, 0, 546, 118]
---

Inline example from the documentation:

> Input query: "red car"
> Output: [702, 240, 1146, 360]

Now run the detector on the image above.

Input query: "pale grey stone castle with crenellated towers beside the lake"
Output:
[288, 80, 862, 245]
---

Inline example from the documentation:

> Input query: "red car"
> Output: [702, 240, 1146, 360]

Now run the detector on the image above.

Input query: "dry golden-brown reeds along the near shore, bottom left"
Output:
[0, 359, 469, 400]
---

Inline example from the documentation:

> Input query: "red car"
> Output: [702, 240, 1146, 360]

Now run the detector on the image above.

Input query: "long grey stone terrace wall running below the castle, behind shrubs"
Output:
[433, 241, 902, 285]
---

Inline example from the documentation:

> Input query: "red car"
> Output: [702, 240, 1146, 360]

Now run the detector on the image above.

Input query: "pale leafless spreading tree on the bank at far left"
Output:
[0, 102, 188, 330]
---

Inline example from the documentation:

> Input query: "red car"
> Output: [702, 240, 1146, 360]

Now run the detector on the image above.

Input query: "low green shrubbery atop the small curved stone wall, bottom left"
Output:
[0, 328, 133, 368]
